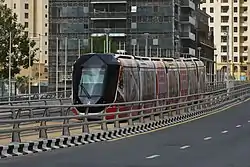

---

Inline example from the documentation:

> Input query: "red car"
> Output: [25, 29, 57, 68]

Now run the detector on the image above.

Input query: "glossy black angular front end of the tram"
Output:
[72, 53, 120, 113]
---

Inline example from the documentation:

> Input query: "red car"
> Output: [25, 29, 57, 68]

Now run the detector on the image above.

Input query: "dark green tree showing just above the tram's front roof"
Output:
[83, 36, 117, 53]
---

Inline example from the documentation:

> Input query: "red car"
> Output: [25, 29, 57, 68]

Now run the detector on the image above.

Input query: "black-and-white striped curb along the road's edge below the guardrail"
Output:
[0, 96, 246, 159]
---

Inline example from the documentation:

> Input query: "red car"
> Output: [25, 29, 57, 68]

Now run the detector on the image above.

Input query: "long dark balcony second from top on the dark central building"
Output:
[91, 12, 127, 20]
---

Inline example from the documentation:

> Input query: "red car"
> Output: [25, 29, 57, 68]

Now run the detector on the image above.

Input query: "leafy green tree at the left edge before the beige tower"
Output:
[0, 0, 38, 78]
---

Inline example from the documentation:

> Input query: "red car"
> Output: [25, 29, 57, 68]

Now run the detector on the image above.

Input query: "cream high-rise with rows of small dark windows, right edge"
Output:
[201, 0, 250, 79]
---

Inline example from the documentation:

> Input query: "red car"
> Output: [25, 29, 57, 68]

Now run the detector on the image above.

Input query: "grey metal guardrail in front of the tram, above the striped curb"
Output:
[0, 83, 250, 142]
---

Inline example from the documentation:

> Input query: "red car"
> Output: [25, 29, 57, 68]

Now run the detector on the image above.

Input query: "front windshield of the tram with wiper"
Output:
[79, 68, 105, 102]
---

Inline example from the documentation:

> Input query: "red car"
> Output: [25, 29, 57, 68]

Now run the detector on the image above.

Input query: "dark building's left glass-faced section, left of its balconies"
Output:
[49, 0, 90, 91]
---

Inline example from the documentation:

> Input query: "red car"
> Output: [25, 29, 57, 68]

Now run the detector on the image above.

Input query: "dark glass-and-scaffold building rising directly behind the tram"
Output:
[49, 0, 215, 89]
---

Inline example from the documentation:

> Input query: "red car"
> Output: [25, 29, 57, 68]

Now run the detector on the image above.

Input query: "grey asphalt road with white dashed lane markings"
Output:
[0, 101, 250, 167]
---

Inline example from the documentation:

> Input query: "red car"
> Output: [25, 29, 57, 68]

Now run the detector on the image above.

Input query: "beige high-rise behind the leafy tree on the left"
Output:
[4, 0, 49, 84]
